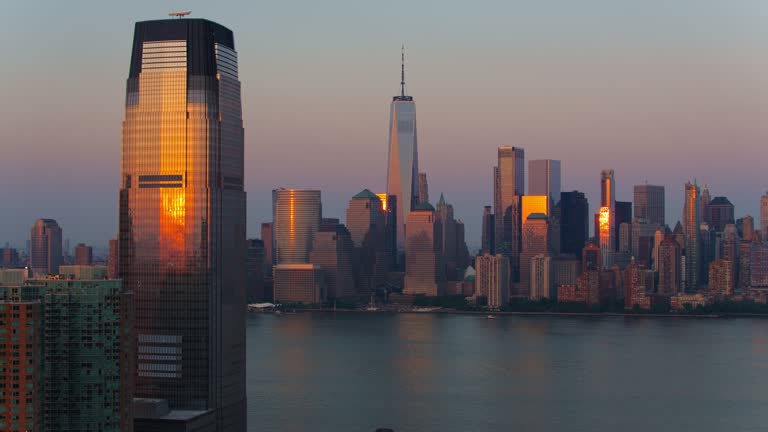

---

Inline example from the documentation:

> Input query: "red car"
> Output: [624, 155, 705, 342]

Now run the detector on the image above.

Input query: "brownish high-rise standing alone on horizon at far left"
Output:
[29, 219, 62, 276]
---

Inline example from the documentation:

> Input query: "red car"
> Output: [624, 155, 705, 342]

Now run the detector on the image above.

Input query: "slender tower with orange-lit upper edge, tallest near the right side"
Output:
[683, 182, 701, 292]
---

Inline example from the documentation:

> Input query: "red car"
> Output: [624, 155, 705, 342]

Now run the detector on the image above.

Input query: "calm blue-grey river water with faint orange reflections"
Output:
[247, 313, 768, 432]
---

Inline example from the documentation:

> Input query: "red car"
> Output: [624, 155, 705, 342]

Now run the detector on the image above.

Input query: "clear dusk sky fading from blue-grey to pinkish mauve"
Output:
[0, 0, 768, 247]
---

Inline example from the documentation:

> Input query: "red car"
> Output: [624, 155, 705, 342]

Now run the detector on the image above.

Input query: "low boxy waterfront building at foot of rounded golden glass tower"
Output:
[273, 264, 327, 305]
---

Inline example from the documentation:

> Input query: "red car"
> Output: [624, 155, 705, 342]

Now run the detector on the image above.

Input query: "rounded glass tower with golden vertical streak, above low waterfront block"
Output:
[272, 189, 322, 264]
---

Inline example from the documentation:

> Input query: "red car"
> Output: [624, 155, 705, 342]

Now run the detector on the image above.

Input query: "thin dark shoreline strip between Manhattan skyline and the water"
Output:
[248, 309, 768, 319]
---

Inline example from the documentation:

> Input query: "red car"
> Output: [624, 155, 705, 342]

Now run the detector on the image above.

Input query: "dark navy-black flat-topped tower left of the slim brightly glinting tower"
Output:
[558, 191, 589, 258]
